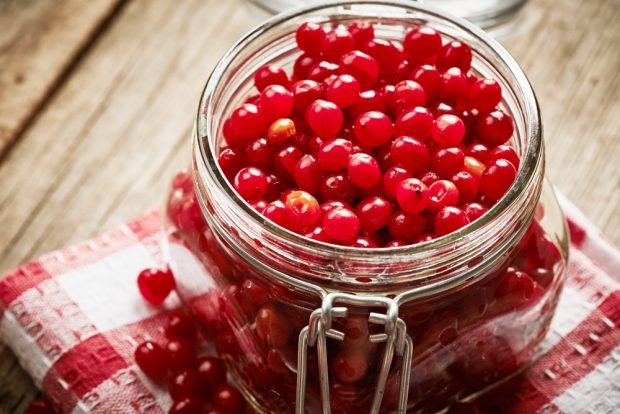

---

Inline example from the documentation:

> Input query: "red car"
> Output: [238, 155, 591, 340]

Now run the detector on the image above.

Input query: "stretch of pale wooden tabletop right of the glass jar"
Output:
[505, 0, 620, 246]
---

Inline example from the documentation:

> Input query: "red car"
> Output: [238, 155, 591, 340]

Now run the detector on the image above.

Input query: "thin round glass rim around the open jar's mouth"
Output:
[195, 0, 543, 268]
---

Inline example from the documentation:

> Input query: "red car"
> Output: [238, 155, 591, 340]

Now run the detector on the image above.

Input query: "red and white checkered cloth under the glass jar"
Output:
[0, 196, 620, 414]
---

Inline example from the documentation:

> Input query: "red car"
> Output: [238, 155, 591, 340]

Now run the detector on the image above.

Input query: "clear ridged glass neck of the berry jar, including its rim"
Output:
[193, 1, 544, 294]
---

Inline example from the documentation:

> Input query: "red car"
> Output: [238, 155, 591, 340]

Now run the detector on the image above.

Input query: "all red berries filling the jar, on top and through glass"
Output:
[167, 6, 565, 414]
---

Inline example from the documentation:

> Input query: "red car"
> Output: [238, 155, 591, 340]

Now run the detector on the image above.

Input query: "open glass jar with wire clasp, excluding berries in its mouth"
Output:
[167, 1, 567, 414]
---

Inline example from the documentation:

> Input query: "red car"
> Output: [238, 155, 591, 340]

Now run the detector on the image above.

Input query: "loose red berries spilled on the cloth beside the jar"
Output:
[134, 269, 246, 414]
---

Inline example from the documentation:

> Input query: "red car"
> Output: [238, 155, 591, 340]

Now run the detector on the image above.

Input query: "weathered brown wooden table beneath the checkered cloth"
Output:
[0, 0, 620, 413]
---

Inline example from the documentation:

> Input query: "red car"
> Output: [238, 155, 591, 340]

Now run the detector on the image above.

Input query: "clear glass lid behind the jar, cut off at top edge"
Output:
[249, 0, 527, 31]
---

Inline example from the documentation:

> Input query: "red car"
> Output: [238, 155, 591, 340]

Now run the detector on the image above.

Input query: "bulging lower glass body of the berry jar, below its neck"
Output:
[166, 171, 566, 413]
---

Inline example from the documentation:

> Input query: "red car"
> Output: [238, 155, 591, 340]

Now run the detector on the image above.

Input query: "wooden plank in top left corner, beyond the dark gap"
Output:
[0, 0, 122, 157]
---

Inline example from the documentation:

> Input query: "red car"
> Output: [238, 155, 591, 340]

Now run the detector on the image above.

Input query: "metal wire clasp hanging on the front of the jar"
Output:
[295, 293, 413, 414]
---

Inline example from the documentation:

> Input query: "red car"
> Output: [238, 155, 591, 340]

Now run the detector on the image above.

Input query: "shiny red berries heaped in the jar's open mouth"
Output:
[219, 21, 519, 247]
